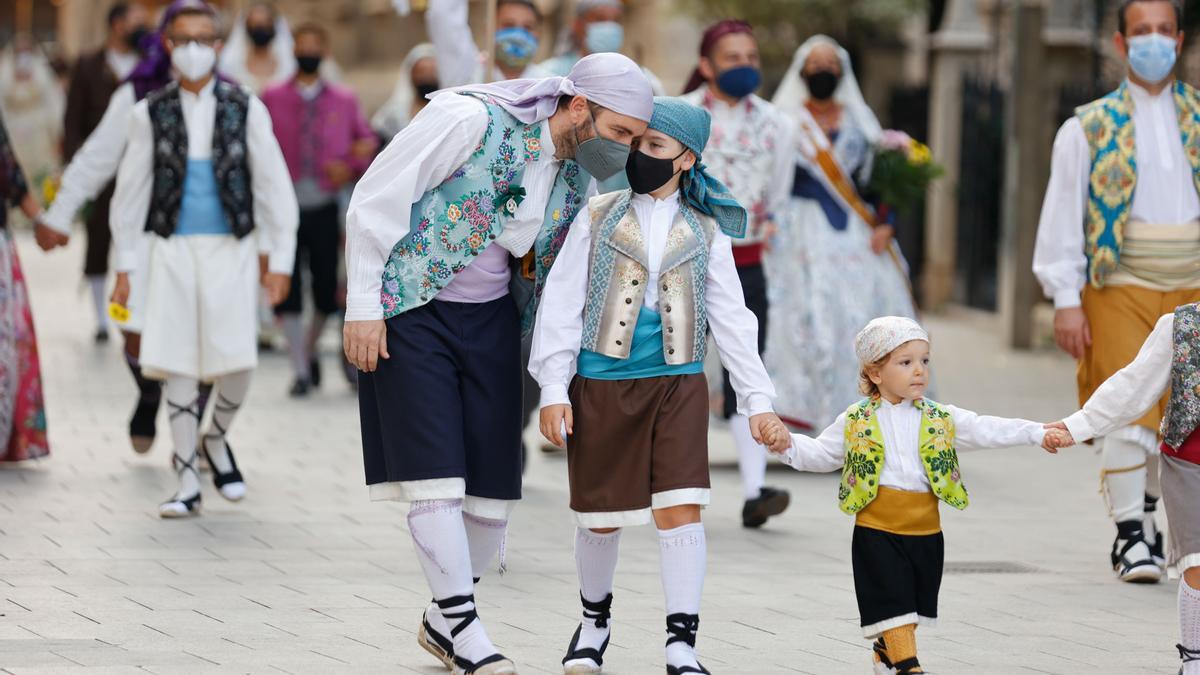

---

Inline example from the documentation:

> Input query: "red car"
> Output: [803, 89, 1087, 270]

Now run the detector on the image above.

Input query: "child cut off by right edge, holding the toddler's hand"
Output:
[1055, 303, 1200, 675]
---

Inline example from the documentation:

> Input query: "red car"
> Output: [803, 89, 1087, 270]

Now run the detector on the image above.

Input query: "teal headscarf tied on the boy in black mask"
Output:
[650, 96, 746, 239]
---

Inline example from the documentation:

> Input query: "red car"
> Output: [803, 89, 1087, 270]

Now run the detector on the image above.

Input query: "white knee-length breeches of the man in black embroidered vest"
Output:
[140, 234, 258, 381]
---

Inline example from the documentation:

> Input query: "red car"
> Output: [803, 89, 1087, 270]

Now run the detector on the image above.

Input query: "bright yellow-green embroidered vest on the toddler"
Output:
[838, 396, 968, 514]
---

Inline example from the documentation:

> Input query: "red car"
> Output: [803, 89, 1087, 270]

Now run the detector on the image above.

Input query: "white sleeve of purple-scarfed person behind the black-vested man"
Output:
[42, 83, 137, 235]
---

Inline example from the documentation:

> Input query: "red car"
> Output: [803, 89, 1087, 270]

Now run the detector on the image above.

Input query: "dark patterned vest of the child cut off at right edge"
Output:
[1162, 303, 1200, 449]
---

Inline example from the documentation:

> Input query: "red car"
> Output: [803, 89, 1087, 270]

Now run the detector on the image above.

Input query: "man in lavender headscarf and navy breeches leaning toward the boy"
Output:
[343, 54, 653, 675]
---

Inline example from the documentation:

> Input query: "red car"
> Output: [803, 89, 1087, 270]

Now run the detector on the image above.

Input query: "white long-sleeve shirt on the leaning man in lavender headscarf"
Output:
[346, 94, 585, 321]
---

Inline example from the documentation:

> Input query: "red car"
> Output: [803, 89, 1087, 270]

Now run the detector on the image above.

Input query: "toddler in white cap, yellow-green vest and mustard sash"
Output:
[767, 316, 1064, 674]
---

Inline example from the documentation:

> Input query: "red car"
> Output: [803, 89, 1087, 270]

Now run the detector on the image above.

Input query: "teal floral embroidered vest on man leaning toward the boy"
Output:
[380, 94, 592, 331]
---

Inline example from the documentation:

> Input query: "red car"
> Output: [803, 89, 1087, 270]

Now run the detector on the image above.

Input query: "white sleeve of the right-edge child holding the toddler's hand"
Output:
[1063, 313, 1175, 443]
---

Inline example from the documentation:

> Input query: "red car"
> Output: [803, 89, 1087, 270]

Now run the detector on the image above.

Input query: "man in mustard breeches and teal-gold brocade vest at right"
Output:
[1033, 0, 1200, 583]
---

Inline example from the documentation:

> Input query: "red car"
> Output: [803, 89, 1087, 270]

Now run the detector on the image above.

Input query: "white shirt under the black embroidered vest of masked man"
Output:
[109, 79, 300, 274]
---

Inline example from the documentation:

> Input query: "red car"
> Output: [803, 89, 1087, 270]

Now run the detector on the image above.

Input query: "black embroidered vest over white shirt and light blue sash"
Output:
[146, 80, 254, 239]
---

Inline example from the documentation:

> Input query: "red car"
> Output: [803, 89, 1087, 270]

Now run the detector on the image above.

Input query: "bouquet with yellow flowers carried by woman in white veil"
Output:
[866, 129, 946, 215]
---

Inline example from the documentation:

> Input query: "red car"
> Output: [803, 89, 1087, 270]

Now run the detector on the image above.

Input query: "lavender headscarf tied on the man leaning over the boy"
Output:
[430, 53, 654, 124]
